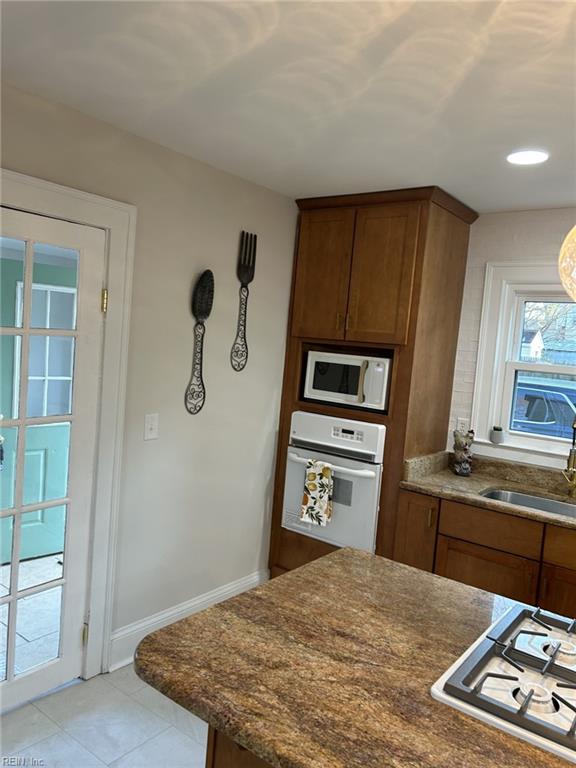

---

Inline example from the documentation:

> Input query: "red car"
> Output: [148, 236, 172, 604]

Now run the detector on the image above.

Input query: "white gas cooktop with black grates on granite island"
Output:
[432, 605, 576, 763]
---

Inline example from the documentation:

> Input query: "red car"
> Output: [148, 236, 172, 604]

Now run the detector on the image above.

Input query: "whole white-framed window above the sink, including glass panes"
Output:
[472, 264, 576, 455]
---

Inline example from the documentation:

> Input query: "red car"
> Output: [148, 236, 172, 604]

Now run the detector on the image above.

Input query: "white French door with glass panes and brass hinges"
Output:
[0, 209, 105, 709]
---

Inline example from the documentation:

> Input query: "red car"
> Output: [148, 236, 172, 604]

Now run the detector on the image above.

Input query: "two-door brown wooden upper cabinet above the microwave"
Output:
[292, 202, 421, 344]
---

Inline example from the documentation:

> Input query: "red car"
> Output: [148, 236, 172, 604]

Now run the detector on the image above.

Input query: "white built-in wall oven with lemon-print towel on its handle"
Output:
[282, 411, 386, 552]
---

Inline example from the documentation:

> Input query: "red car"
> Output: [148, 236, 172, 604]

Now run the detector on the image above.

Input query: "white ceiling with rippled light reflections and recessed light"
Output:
[2, 0, 576, 211]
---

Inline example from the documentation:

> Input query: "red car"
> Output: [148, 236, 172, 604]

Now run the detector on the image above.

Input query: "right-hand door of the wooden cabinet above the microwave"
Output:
[346, 203, 420, 344]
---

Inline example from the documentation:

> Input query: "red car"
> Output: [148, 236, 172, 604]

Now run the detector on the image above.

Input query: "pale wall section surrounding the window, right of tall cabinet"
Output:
[448, 208, 576, 453]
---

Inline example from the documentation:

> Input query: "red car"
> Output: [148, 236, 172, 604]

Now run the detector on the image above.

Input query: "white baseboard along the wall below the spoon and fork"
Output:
[109, 571, 269, 672]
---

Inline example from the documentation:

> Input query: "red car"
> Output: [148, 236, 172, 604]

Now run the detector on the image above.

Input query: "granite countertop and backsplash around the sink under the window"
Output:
[400, 452, 576, 528]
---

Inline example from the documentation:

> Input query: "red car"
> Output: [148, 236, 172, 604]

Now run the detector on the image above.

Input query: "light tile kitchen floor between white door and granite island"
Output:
[0, 665, 208, 768]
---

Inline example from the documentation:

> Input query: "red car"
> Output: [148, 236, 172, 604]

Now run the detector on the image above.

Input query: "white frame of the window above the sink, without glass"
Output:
[470, 262, 576, 468]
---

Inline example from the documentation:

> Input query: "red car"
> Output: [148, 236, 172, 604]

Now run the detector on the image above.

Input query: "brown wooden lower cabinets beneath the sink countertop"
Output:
[394, 489, 576, 618]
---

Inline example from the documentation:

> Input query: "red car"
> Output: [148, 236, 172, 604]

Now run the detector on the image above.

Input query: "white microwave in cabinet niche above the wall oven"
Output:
[304, 350, 390, 411]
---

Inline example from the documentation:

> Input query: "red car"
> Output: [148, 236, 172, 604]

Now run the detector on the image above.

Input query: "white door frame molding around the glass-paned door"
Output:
[0, 169, 137, 678]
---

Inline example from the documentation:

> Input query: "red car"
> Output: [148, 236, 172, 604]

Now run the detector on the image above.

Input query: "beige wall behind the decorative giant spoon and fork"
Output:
[2, 88, 296, 628]
